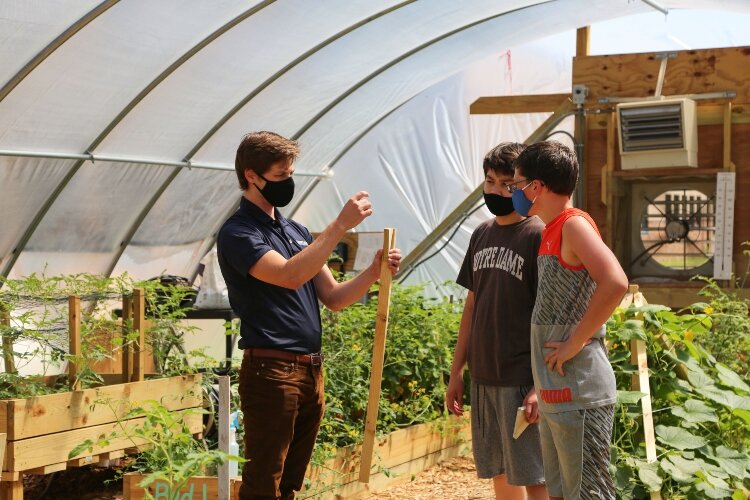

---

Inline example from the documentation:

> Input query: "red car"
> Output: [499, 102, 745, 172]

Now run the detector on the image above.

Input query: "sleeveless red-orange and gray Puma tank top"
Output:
[531, 208, 616, 413]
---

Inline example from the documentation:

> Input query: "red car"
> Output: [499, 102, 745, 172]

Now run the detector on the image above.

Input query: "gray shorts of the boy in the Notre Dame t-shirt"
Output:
[471, 383, 544, 486]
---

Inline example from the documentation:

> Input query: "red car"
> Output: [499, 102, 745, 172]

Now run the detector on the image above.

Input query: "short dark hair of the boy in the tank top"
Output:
[514, 141, 578, 196]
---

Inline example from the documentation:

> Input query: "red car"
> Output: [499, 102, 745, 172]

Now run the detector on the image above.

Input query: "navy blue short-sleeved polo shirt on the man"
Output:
[216, 197, 321, 354]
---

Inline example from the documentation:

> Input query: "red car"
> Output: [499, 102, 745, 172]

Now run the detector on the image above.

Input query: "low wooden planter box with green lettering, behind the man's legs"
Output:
[123, 417, 471, 500]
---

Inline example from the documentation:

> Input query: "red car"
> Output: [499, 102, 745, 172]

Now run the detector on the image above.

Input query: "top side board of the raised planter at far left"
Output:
[0, 374, 203, 442]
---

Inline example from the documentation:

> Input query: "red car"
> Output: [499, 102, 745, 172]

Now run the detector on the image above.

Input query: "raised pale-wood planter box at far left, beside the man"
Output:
[0, 375, 203, 500]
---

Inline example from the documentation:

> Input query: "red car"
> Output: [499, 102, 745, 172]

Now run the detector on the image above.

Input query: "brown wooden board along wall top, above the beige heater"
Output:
[573, 47, 750, 108]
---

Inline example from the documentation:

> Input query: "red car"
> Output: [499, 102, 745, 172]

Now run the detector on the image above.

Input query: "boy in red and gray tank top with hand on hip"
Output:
[512, 141, 628, 500]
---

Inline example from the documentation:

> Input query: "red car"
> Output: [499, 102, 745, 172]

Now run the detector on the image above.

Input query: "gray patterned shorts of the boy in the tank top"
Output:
[539, 405, 615, 500]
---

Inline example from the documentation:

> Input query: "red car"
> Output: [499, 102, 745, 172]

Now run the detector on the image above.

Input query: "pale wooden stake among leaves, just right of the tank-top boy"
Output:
[623, 285, 661, 500]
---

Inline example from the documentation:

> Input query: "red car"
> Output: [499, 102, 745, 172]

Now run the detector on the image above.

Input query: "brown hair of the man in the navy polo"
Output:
[234, 131, 299, 191]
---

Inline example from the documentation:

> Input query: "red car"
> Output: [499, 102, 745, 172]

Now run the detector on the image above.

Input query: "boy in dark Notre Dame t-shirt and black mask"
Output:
[445, 143, 548, 500]
